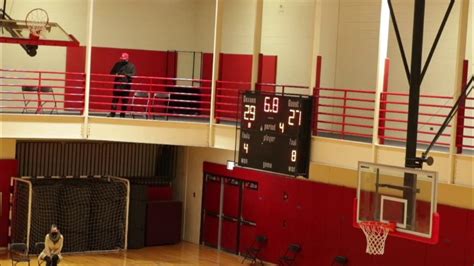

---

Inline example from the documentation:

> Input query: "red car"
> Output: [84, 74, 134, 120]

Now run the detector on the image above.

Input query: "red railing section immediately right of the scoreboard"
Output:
[313, 88, 375, 139]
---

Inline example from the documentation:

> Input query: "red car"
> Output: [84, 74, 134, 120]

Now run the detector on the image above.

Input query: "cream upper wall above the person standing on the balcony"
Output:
[92, 0, 213, 51]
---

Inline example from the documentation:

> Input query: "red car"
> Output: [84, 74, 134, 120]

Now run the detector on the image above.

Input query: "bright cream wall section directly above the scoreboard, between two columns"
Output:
[261, 0, 316, 86]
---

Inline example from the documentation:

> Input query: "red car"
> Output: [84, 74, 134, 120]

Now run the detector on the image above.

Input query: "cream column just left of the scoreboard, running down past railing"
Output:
[209, 0, 225, 147]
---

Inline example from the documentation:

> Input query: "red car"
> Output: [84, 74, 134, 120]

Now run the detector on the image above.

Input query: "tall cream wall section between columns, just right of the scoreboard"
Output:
[318, 0, 380, 134]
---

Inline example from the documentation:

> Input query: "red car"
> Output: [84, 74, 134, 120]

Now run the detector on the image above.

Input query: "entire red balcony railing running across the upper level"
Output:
[0, 65, 474, 153]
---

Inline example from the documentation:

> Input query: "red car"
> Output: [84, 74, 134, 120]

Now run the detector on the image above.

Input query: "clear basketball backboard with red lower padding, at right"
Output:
[354, 162, 439, 244]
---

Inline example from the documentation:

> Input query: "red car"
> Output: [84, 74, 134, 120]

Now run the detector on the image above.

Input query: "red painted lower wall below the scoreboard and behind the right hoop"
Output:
[204, 162, 474, 266]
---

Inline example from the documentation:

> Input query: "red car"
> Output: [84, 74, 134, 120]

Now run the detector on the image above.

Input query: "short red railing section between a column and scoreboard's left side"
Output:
[214, 80, 251, 123]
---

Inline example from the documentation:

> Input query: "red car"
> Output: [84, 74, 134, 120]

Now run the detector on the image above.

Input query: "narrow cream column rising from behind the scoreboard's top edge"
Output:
[250, 0, 263, 90]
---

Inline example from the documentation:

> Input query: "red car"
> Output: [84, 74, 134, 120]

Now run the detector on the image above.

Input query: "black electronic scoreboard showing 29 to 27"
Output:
[238, 92, 312, 177]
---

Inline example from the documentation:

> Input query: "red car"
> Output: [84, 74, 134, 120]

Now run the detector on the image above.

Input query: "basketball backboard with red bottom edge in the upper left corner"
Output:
[0, 19, 79, 46]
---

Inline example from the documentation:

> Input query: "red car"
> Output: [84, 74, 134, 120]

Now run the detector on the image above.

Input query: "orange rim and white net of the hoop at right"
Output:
[359, 221, 395, 255]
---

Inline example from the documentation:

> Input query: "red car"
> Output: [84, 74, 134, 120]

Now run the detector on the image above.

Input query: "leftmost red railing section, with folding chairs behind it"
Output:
[0, 69, 85, 114]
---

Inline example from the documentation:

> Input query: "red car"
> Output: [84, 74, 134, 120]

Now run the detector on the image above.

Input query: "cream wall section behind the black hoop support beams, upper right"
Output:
[388, 0, 461, 95]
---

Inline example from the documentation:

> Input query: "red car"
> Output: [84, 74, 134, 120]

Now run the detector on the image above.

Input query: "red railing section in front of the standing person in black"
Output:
[89, 74, 211, 119]
